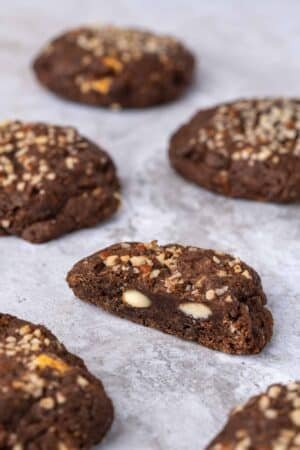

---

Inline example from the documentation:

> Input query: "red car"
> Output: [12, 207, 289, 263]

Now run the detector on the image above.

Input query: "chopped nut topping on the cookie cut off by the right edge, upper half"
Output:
[191, 98, 300, 165]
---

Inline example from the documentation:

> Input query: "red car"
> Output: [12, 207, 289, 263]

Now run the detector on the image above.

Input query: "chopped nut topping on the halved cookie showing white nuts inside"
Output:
[99, 241, 260, 308]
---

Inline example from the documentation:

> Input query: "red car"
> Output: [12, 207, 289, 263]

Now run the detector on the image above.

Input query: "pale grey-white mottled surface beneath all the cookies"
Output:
[0, 0, 300, 450]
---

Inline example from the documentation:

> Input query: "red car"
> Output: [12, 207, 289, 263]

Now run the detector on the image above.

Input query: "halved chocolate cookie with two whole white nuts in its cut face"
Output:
[67, 241, 273, 354]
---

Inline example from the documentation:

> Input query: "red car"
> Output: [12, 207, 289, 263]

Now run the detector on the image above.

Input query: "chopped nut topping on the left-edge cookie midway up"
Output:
[0, 121, 98, 191]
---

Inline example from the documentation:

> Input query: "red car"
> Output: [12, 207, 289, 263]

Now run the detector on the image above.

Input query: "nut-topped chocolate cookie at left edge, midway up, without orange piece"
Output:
[0, 122, 119, 242]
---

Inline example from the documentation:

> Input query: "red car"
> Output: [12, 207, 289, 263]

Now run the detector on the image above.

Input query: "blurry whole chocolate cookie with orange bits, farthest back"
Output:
[33, 26, 194, 108]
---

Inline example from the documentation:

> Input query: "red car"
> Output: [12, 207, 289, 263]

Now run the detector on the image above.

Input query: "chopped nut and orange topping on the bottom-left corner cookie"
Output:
[0, 320, 96, 450]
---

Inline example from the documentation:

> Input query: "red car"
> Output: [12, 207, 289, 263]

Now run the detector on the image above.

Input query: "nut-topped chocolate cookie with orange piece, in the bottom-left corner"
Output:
[0, 314, 113, 450]
